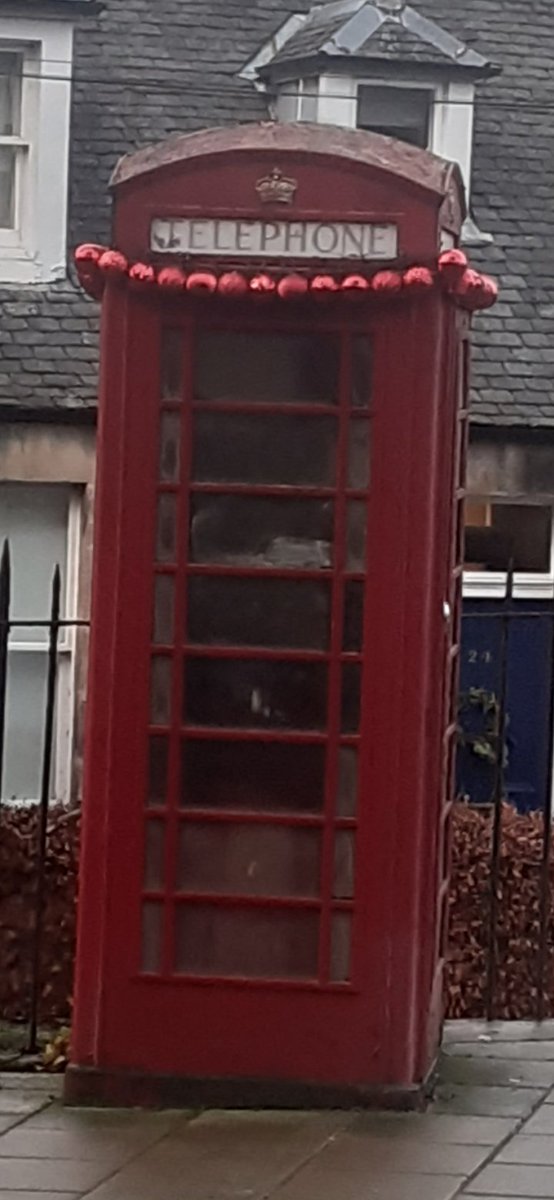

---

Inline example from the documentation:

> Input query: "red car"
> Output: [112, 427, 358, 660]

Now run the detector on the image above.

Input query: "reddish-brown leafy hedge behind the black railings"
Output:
[0, 804, 554, 1022]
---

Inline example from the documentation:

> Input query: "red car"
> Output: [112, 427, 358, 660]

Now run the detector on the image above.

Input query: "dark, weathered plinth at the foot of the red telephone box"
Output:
[64, 1066, 434, 1112]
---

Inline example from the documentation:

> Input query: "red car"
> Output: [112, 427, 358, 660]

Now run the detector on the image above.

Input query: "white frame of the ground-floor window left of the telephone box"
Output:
[2, 484, 82, 805]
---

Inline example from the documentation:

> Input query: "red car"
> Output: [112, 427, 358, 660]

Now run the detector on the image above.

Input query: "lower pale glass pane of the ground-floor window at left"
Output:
[2, 650, 55, 800]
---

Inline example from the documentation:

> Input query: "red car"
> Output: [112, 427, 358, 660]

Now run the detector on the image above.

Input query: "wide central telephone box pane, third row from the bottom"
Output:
[181, 740, 326, 812]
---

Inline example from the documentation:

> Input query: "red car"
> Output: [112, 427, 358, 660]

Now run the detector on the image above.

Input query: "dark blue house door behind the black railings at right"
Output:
[457, 600, 553, 812]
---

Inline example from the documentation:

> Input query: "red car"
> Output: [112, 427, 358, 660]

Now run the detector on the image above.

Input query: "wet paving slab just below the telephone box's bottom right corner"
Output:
[350, 1105, 520, 1147]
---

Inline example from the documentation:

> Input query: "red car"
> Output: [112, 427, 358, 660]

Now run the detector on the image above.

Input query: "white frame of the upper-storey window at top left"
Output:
[0, 16, 73, 284]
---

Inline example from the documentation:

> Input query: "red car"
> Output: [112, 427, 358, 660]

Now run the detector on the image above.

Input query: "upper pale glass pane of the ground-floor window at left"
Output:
[0, 484, 68, 643]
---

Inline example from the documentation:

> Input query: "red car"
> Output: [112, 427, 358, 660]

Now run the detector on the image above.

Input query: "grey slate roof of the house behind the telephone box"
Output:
[0, 0, 554, 430]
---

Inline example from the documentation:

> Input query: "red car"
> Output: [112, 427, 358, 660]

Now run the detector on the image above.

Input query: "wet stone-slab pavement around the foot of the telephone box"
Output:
[0, 1022, 554, 1200]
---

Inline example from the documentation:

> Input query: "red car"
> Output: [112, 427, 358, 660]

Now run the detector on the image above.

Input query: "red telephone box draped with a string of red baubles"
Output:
[67, 125, 494, 1106]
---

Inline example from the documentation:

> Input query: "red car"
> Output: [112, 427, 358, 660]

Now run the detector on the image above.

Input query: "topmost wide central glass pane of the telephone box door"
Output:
[194, 331, 339, 404]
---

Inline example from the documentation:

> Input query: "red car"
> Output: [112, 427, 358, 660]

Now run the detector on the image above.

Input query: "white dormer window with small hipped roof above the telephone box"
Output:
[241, 0, 496, 244]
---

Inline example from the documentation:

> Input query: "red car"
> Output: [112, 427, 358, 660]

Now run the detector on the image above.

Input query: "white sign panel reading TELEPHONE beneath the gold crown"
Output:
[150, 217, 398, 262]
